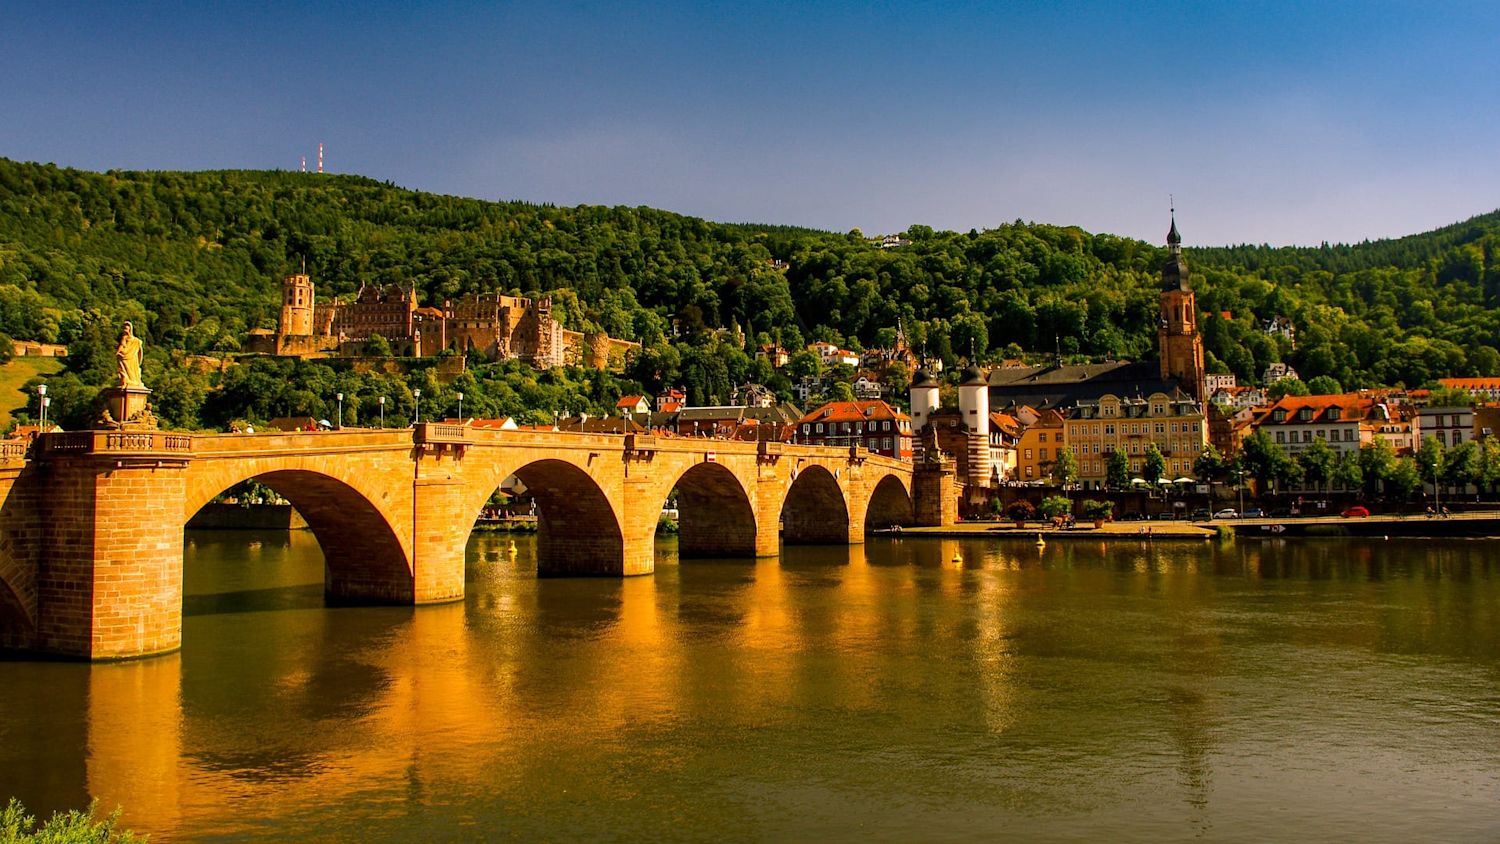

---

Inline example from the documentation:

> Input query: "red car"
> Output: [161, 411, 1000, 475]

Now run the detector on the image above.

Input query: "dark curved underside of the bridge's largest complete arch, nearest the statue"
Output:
[195, 469, 416, 604]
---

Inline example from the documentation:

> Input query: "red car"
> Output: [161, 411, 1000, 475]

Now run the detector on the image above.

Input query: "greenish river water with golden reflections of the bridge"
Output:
[0, 531, 1500, 843]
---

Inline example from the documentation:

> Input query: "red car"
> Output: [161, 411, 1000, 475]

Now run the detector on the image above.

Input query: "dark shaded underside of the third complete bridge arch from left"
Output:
[675, 463, 756, 558]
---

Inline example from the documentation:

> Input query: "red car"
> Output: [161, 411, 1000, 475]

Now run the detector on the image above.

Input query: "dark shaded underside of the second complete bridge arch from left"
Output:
[497, 459, 626, 576]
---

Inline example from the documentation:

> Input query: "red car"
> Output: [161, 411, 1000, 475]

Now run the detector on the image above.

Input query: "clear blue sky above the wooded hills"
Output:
[0, 1, 1500, 244]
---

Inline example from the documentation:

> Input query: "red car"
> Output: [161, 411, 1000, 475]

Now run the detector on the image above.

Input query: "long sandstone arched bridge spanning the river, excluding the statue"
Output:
[0, 423, 957, 660]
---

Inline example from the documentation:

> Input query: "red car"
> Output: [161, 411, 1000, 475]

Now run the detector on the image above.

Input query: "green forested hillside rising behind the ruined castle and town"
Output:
[0, 159, 1500, 410]
